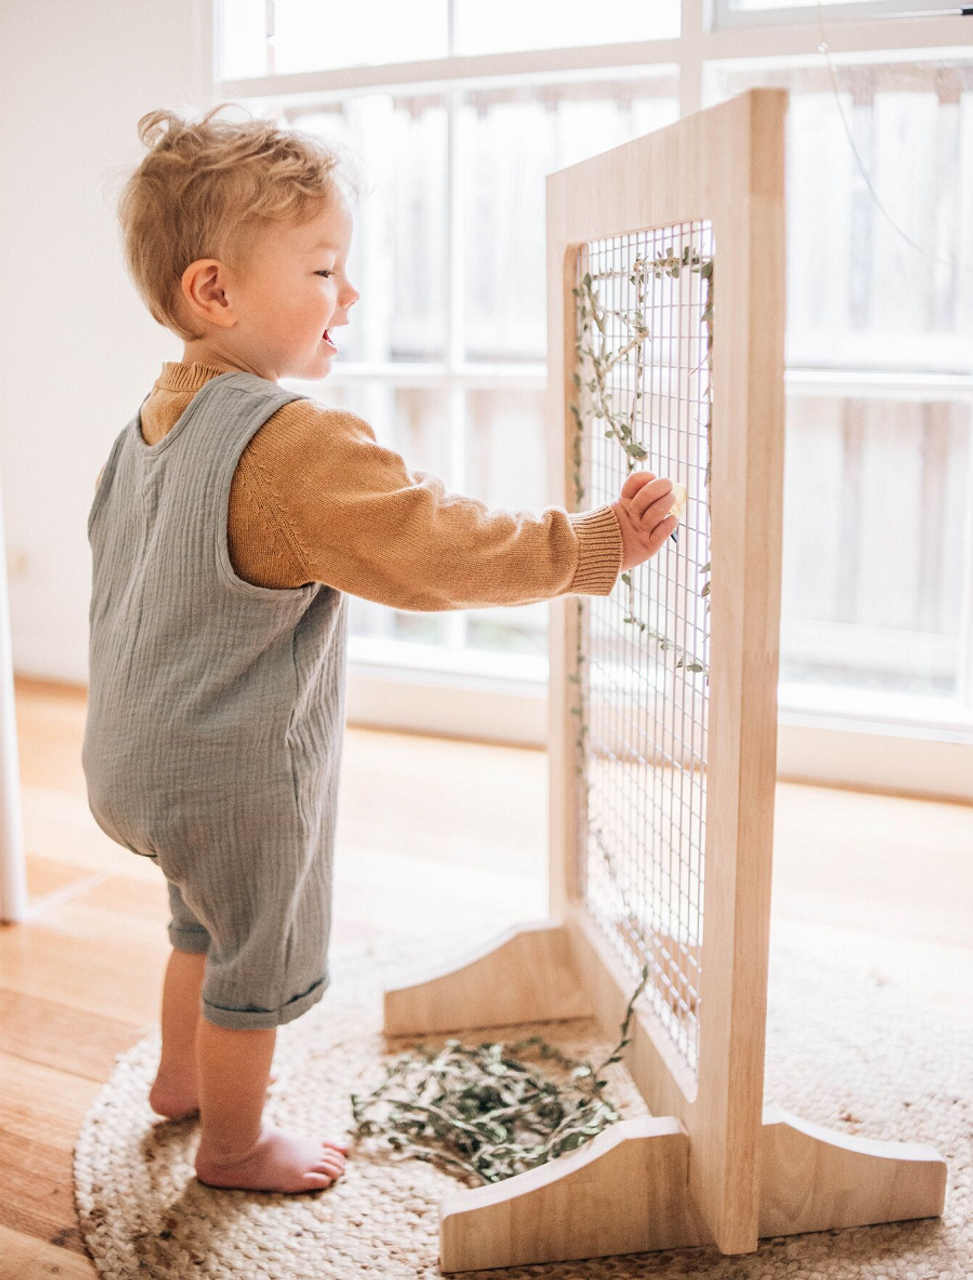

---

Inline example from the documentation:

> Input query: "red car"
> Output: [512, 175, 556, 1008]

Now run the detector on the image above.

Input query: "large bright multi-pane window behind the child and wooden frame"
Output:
[215, 0, 973, 778]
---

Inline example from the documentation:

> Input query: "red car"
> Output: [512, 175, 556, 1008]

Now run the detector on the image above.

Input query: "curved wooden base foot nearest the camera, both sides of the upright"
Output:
[439, 1106, 946, 1272]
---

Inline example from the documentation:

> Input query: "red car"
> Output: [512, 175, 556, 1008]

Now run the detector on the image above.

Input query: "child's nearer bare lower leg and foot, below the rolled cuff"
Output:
[196, 1016, 348, 1192]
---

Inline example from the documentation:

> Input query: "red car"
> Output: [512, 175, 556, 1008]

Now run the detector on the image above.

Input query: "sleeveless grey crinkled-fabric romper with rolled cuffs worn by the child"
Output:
[82, 372, 348, 1028]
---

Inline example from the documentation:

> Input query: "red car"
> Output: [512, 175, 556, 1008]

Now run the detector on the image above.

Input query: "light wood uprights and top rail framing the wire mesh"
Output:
[547, 90, 787, 1257]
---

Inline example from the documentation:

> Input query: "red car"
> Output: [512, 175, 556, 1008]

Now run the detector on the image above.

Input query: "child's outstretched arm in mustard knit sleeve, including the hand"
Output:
[236, 401, 675, 611]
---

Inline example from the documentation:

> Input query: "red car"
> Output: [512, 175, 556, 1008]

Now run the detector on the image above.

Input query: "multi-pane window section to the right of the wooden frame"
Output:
[704, 52, 973, 714]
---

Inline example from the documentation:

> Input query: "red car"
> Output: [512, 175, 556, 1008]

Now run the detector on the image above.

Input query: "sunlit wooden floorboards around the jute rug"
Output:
[0, 677, 973, 1280]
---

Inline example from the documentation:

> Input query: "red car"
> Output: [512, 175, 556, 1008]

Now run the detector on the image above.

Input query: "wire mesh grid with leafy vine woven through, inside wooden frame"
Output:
[570, 221, 713, 1076]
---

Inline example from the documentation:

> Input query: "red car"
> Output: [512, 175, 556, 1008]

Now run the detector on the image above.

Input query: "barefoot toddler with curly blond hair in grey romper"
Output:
[82, 106, 677, 1192]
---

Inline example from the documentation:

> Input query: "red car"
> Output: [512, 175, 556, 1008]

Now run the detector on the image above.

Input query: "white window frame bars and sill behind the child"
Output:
[208, 0, 973, 801]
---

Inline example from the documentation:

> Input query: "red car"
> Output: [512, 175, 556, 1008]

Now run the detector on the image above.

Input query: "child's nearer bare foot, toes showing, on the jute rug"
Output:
[196, 1120, 348, 1192]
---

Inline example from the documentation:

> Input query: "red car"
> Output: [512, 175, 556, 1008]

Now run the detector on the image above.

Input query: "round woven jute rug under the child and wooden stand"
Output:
[74, 933, 973, 1280]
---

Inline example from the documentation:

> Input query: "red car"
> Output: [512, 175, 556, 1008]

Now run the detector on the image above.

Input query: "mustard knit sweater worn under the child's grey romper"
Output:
[99, 362, 622, 611]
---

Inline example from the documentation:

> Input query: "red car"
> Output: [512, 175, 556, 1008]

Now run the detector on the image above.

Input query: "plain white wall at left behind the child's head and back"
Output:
[0, 0, 213, 685]
